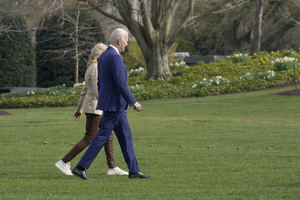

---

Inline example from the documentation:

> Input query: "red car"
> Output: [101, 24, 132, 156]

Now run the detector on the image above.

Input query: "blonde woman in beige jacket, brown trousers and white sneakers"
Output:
[55, 43, 128, 175]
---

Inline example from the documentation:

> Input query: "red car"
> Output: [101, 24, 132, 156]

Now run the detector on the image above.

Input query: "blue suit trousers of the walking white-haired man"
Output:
[78, 110, 140, 173]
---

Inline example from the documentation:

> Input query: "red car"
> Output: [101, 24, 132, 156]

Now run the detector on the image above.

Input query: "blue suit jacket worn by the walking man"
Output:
[96, 46, 136, 111]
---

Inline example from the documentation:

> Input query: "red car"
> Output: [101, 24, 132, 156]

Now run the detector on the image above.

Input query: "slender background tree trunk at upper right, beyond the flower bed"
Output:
[250, 0, 264, 53]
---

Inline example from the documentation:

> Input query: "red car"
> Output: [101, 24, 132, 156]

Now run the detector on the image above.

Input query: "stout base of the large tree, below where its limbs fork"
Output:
[143, 46, 172, 80]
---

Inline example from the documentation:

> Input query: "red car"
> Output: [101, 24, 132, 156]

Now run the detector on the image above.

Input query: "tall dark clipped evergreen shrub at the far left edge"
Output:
[0, 16, 36, 87]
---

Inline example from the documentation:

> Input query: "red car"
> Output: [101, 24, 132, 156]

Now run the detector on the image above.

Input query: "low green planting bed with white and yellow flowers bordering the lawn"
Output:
[0, 52, 300, 108]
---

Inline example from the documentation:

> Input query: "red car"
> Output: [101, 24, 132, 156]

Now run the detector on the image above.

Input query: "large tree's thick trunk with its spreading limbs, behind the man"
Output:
[80, 0, 194, 80]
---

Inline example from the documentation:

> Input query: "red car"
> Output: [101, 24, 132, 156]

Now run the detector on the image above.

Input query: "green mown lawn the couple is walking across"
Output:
[0, 87, 300, 200]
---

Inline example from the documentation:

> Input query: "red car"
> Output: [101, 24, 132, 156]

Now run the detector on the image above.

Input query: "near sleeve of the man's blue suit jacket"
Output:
[112, 55, 136, 106]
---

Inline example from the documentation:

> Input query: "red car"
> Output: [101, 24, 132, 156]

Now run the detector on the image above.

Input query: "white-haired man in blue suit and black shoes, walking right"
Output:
[72, 28, 152, 180]
